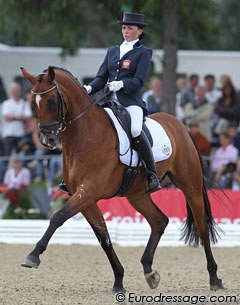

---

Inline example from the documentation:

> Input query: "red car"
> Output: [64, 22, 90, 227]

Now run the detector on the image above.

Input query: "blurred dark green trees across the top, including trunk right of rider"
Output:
[0, 0, 240, 113]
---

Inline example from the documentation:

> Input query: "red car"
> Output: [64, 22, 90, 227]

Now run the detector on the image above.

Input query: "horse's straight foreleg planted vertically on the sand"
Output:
[82, 204, 125, 292]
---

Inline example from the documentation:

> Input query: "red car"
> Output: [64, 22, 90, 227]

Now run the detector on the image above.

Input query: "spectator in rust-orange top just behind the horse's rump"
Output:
[188, 120, 211, 156]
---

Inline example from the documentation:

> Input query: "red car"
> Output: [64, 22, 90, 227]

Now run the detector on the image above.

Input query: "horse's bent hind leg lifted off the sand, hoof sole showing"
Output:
[127, 192, 169, 289]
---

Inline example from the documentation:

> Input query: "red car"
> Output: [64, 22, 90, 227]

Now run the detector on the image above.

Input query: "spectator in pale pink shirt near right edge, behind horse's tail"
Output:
[212, 132, 238, 182]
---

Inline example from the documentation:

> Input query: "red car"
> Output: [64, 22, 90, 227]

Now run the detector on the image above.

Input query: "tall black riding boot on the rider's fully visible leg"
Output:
[133, 131, 161, 193]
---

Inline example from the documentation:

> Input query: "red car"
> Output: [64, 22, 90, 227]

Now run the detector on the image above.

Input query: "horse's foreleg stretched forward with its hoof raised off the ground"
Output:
[21, 194, 91, 268]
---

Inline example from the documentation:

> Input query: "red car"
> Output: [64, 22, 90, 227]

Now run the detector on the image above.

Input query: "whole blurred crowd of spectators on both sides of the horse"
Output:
[0, 74, 240, 195]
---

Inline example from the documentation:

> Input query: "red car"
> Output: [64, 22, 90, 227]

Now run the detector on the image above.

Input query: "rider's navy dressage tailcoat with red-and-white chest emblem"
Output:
[89, 41, 152, 113]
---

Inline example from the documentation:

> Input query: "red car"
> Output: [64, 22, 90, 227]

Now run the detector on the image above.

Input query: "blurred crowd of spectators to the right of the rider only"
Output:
[143, 74, 240, 190]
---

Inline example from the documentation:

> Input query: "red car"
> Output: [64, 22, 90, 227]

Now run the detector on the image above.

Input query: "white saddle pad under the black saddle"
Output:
[104, 108, 172, 166]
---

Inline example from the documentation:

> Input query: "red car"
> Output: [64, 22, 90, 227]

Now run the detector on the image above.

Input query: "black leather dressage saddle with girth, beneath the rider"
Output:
[101, 100, 153, 197]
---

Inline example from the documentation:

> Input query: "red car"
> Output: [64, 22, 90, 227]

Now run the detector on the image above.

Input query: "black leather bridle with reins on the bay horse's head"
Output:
[31, 80, 98, 136]
